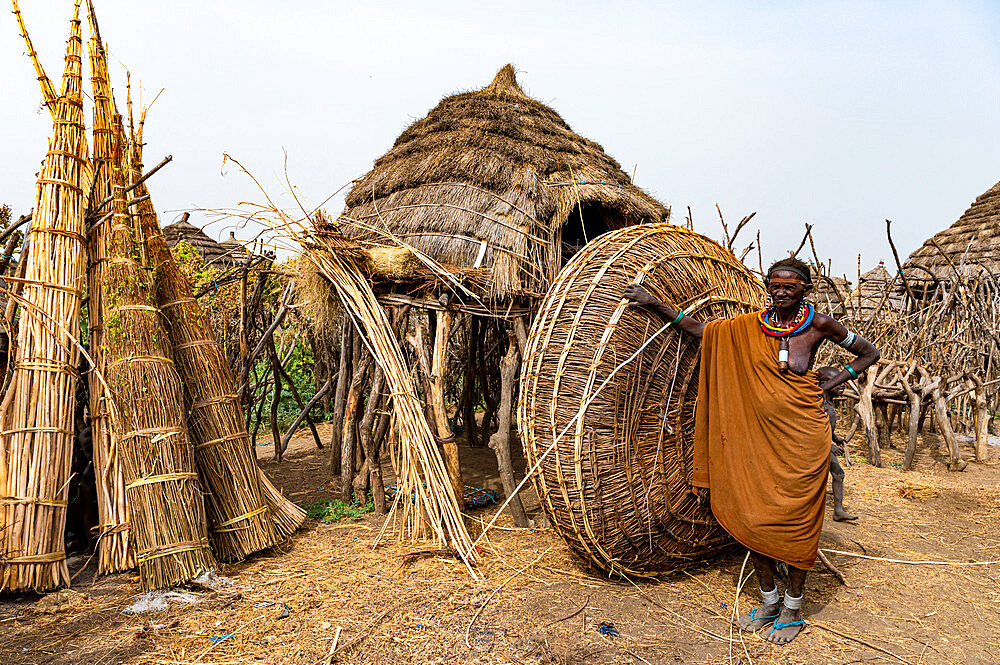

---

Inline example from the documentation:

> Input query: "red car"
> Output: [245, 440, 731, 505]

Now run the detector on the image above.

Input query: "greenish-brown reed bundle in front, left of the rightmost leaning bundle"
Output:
[95, 118, 215, 589]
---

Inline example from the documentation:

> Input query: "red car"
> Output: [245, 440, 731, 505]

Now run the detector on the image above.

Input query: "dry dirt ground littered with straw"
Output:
[0, 422, 1000, 665]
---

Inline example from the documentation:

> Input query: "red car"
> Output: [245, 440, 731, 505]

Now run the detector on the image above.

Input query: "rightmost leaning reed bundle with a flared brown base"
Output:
[125, 120, 292, 562]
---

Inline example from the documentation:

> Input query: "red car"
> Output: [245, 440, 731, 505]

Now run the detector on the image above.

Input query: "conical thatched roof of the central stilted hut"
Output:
[345, 65, 667, 297]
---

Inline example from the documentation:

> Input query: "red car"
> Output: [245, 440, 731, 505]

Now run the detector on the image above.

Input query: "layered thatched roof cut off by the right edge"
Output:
[903, 182, 1000, 281]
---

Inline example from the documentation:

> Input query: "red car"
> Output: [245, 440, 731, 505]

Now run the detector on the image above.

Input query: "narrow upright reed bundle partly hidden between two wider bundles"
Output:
[87, 1, 135, 574]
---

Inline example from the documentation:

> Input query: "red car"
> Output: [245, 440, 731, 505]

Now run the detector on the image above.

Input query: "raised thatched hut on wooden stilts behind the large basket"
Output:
[333, 65, 668, 524]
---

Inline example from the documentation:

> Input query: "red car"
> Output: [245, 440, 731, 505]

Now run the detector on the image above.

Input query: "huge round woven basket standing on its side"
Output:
[518, 224, 765, 576]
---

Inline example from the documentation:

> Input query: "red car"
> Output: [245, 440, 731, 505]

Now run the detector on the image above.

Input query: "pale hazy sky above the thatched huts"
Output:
[0, 0, 1000, 281]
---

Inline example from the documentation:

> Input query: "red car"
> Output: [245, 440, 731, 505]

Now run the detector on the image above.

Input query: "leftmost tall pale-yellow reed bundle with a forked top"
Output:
[0, 0, 91, 591]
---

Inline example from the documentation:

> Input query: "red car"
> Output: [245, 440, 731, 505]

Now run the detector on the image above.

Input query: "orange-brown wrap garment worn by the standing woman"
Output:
[692, 313, 830, 570]
